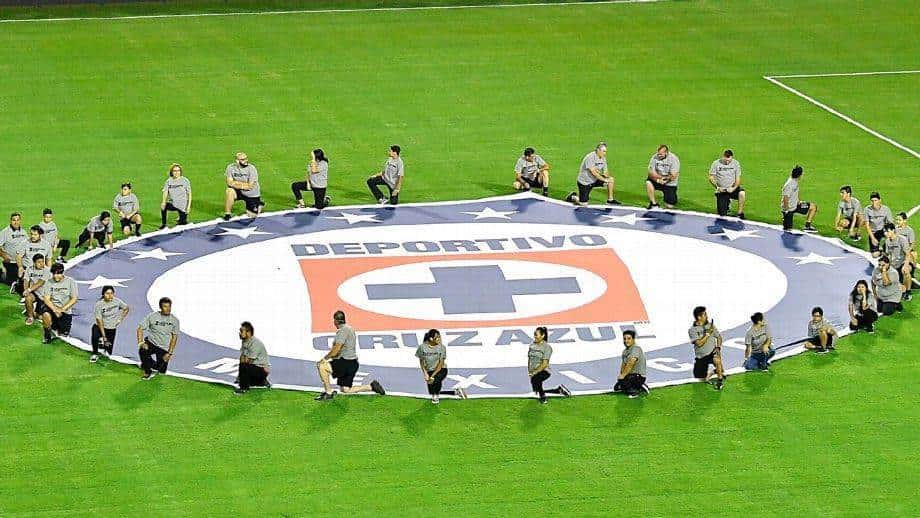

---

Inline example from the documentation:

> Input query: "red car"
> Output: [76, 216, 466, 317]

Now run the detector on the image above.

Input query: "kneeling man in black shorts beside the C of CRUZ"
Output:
[315, 311, 386, 401]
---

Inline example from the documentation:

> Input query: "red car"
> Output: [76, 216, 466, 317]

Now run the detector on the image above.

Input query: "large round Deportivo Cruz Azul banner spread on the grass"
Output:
[67, 193, 872, 397]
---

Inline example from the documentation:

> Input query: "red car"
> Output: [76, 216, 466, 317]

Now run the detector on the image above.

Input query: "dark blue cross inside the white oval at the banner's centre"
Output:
[365, 265, 581, 315]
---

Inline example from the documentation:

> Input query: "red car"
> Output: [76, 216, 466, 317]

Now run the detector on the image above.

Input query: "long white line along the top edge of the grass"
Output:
[0, 0, 668, 23]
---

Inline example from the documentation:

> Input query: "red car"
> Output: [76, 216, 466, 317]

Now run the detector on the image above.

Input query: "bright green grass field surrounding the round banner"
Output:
[0, 0, 920, 516]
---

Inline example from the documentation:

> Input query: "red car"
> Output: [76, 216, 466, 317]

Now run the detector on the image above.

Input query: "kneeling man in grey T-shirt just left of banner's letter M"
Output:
[137, 297, 179, 381]
